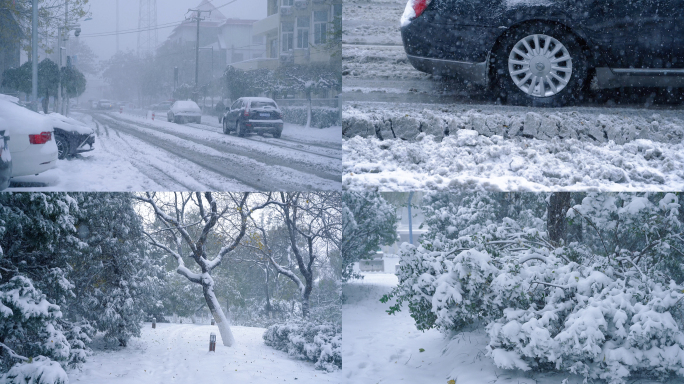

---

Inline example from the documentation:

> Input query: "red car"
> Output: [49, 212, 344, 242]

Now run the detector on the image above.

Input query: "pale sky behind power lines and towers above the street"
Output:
[81, 0, 267, 60]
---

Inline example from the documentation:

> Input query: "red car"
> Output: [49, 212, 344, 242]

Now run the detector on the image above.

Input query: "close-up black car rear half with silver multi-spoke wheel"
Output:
[401, 0, 684, 105]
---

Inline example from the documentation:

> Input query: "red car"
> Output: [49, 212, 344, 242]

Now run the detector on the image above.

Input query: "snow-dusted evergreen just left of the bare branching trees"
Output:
[67, 193, 161, 346]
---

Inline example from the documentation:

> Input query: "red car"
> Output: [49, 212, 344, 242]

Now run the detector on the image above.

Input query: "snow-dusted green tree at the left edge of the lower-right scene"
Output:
[340, 192, 399, 280]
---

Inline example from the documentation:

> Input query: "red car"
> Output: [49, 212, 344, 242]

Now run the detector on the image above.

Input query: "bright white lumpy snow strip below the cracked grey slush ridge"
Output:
[342, 130, 684, 191]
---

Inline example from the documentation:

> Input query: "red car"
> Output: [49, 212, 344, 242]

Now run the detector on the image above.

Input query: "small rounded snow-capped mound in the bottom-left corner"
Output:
[0, 356, 69, 384]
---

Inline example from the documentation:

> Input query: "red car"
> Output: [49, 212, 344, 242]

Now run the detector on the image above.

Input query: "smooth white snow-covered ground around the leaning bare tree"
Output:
[68, 323, 341, 384]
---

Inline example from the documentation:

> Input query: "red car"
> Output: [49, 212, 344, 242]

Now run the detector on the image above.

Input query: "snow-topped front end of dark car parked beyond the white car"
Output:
[48, 113, 95, 160]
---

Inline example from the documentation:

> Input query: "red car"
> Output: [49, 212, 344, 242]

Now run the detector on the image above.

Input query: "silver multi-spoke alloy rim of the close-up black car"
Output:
[508, 34, 572, 97]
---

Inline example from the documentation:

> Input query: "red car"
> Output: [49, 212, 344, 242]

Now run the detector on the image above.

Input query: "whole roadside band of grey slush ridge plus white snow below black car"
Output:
[343, 103, 684, 191]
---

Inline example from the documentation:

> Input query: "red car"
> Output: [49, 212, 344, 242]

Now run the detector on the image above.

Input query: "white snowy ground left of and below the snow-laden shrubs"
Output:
[342, 273, 674, 384]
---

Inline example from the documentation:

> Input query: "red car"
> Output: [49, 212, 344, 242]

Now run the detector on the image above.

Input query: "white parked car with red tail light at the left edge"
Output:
[0, 95, 57, 177]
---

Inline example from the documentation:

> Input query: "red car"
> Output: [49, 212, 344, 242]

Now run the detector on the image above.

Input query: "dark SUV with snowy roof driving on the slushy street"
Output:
[223, 97, 283, 138]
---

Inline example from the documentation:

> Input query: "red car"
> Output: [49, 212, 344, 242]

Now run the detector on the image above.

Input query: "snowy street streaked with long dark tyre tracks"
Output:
[8, 111, 342, 191]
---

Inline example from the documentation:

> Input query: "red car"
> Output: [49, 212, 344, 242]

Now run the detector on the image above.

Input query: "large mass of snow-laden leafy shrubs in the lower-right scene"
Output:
[384, 193, 684, 383]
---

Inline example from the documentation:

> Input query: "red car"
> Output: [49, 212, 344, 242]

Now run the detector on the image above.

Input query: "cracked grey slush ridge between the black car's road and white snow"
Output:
[342, 104, 684, 144]
